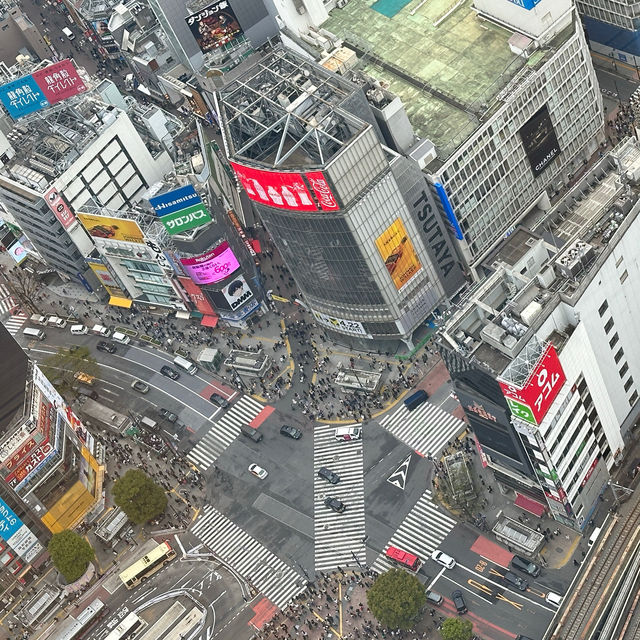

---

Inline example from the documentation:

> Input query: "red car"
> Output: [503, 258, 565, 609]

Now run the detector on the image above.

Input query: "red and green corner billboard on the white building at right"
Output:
[498, 343, 567, 424]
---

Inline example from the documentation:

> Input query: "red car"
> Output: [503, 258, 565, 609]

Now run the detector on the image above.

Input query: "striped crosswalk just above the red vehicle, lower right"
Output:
[371, 489, 456, 573]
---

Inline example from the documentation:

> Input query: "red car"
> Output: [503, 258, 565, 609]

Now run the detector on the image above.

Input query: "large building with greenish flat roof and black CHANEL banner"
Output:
[322, 0, 603, 275]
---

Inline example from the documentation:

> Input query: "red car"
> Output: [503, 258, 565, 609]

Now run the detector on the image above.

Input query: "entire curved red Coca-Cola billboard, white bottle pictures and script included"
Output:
[230, 162, 340, 211]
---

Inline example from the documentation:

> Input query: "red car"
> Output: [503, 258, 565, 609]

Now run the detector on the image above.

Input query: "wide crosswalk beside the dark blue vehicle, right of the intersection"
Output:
[380, 402, 465, 456]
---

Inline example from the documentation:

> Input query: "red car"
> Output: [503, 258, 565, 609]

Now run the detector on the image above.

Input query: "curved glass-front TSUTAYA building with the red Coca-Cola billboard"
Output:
[218, 47, 464, 344]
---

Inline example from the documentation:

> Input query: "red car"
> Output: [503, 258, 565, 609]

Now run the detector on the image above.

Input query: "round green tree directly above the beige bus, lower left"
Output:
[112, 469, 167, 524]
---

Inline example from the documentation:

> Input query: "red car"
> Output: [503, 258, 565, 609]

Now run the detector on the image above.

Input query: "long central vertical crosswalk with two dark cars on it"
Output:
[313, 425, 366, 571]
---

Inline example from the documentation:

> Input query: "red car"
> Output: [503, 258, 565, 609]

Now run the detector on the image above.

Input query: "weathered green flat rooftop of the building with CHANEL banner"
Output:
[322, 0, 568, 160]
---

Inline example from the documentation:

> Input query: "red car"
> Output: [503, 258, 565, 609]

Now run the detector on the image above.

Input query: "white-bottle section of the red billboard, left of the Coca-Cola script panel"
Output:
[229, 162, 318, 211]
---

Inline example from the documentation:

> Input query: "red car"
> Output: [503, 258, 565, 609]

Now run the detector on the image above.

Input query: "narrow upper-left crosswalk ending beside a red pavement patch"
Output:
[187, 395, 264, 471]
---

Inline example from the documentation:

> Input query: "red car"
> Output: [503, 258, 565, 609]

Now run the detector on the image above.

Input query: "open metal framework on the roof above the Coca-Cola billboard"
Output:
[219, 47, 366, 168]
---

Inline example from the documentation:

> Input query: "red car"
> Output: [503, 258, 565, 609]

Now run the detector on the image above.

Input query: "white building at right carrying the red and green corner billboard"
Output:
[440, 140, 640, 529]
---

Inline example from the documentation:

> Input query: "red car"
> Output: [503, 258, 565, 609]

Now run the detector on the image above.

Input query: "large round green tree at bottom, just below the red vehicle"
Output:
[367, 569, 427, 629]
